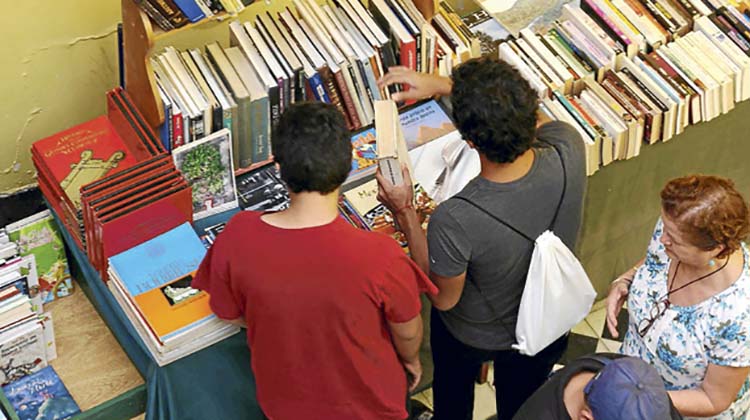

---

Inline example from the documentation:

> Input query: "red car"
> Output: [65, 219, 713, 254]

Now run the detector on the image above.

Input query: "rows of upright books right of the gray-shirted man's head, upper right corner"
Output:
[499, 0, 750, 175]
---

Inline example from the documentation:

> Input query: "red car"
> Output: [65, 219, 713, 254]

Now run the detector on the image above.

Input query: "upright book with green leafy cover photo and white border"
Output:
[172, 128, 239, 219]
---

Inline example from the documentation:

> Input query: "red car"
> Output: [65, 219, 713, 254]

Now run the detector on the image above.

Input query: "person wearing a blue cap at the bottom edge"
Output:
[513, 353, 682, 420]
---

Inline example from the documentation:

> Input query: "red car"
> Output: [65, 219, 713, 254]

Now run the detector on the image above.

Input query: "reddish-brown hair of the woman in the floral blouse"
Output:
[661, 175, 750, 258]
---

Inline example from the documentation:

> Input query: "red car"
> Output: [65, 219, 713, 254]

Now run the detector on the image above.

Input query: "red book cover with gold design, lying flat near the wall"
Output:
[32, 116, 137, 209]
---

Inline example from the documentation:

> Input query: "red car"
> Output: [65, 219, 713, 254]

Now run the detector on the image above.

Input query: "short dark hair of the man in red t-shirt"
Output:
[271, 102, 352, 194]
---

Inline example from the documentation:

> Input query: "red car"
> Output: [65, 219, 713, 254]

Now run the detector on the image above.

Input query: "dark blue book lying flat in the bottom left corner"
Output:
[3, 366, 81, 420]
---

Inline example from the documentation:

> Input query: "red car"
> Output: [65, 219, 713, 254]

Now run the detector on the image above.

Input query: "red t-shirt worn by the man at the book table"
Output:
[193, 211, 434, 420]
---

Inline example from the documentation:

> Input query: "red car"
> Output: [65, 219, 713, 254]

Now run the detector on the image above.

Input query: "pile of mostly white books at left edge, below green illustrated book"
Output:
[0, 254, 57, 385]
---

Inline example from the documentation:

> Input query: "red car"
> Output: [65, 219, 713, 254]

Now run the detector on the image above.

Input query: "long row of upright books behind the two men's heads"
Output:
[151, 0, 481, 170]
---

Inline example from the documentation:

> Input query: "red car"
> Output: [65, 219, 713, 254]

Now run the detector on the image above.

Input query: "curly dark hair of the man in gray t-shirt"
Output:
[451, 56, 539, 163]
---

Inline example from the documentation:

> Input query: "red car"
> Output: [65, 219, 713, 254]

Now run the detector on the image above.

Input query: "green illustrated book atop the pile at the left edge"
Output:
[6, 210, 73, 303]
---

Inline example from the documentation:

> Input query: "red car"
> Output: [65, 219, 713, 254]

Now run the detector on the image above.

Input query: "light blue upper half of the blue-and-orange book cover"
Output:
[109, 222, 206, 297]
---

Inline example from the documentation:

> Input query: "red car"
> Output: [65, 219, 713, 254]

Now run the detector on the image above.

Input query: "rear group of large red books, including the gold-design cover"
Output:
[31, 88, 167, 249]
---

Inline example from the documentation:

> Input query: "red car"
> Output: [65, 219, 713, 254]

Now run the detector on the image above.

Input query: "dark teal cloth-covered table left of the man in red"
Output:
[53, 210, 264, 420]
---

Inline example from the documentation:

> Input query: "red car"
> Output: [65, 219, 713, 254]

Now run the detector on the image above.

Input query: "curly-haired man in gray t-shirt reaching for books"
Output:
[377, 57, 586, 420]
